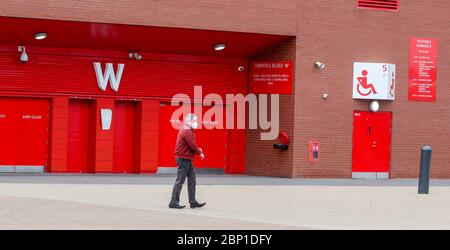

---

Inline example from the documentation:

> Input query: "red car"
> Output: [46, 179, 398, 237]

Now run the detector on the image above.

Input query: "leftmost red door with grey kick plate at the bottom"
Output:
[0, 98, 49, 172]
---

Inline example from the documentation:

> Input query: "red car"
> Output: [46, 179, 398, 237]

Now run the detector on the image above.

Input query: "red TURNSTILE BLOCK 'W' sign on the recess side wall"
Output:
[250, 61, 293, 94]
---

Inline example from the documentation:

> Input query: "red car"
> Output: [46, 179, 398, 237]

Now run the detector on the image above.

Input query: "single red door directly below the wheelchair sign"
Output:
[352, 111, 391, 178]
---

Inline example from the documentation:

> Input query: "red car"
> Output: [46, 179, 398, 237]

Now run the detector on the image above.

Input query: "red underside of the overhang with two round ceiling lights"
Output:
[0, 17, 290, 58]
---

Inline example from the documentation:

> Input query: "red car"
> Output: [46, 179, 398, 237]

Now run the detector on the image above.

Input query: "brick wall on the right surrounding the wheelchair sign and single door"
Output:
[293, 0, 450, 178]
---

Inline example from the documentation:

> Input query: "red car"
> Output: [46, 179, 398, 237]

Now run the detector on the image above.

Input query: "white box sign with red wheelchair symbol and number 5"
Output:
[353, 62, 395, 101]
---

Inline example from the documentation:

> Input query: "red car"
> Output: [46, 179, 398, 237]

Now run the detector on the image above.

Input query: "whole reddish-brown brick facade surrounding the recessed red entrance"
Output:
[0, 0, 450, 178]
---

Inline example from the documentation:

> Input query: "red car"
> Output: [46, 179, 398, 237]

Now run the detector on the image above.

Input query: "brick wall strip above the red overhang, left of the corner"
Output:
[0, 0, 297, 35]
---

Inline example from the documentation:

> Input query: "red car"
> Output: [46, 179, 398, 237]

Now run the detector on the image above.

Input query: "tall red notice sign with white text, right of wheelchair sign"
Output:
[408, 37, 438, 102]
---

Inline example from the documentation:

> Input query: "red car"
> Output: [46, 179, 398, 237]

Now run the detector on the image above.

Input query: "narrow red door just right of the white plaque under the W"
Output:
[113, 101, 139, 173]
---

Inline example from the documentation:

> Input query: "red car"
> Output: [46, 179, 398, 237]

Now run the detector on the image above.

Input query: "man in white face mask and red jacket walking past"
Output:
[169, 114, 206, 209]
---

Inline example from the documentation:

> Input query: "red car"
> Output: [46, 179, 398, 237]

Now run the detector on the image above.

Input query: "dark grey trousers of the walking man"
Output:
[170, 158, 197, 204]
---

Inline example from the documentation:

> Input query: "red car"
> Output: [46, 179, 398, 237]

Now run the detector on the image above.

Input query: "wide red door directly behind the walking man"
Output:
[158, 103, 227, 169]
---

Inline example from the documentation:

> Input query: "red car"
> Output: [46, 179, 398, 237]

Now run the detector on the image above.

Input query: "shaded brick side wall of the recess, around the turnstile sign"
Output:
[246, 38, 296, 177]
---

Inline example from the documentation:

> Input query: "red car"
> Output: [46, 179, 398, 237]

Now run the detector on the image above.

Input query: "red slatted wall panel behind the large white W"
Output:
[0, 48, 237, 98]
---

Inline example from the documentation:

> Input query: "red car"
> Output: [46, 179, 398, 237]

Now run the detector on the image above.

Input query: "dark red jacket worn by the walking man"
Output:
[175, 125, 201, 160]
